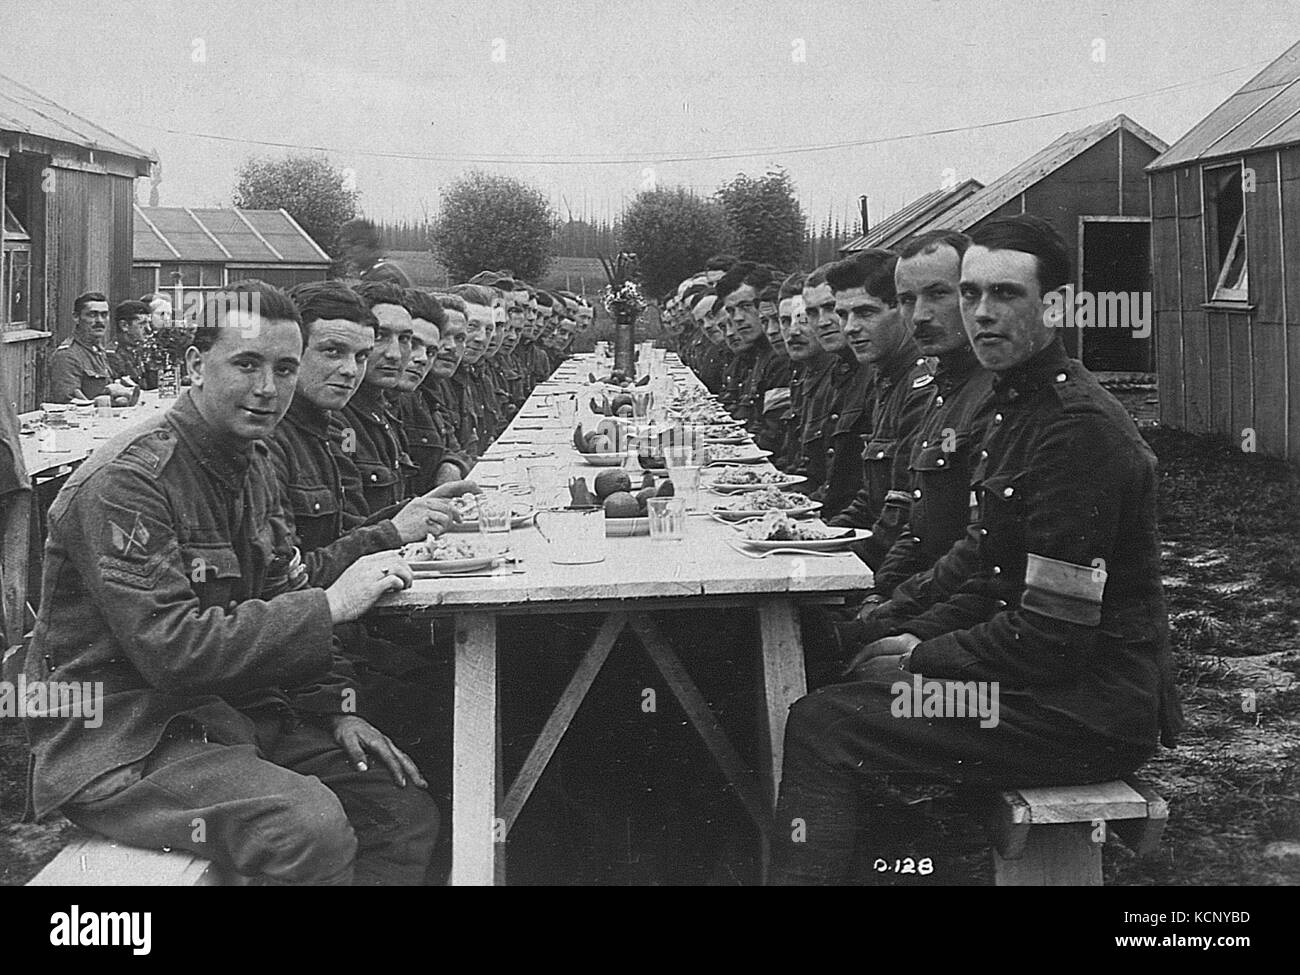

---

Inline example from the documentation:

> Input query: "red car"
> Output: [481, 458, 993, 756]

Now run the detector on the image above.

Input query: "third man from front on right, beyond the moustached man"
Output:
[827, 250, 930, 569]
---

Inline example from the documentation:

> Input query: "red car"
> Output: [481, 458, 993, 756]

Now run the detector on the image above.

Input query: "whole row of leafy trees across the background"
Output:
[231, 153, 861, 296]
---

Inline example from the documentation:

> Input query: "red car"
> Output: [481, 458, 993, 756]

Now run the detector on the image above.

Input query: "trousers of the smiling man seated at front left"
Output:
[62, 711, 438, 885]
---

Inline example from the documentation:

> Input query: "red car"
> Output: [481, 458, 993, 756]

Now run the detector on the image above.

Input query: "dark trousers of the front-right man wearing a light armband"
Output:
[771, 657, 1154, 884]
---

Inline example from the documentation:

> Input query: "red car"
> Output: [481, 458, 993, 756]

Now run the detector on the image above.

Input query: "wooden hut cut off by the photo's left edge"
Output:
[0, 75, 152, 412]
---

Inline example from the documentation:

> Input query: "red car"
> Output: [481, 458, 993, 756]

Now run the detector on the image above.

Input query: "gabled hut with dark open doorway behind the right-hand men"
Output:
[909, 114, 1169, 372]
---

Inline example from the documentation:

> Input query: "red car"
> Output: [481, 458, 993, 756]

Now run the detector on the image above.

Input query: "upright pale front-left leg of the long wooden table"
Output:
[451, 612, 499, 887]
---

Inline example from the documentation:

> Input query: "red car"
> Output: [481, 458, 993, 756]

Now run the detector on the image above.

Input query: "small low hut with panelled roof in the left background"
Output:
[131, 207, 330, 308]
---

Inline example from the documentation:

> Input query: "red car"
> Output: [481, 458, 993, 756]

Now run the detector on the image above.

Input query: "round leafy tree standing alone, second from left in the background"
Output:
[429, 170, 555, 281]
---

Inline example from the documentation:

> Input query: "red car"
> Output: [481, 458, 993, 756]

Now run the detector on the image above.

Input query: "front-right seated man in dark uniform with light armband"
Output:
[772, 215, 1182, 884]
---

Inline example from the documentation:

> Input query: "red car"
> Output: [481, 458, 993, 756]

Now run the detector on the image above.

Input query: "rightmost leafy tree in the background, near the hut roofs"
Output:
[718, 168, 806, 268]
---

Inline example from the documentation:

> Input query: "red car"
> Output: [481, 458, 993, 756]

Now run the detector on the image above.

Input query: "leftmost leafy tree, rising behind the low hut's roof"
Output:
[233, 153, 358, 260]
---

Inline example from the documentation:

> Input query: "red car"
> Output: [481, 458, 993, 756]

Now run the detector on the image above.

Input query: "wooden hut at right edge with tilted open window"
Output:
[1147, 43, 1300, 460]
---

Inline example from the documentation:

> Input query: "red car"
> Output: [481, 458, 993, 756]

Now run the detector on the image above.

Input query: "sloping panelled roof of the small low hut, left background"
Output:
[134, 207, 330, 264]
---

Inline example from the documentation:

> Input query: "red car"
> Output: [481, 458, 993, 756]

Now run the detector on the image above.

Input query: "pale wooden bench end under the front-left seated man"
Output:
[27, 835, 248, 887]
